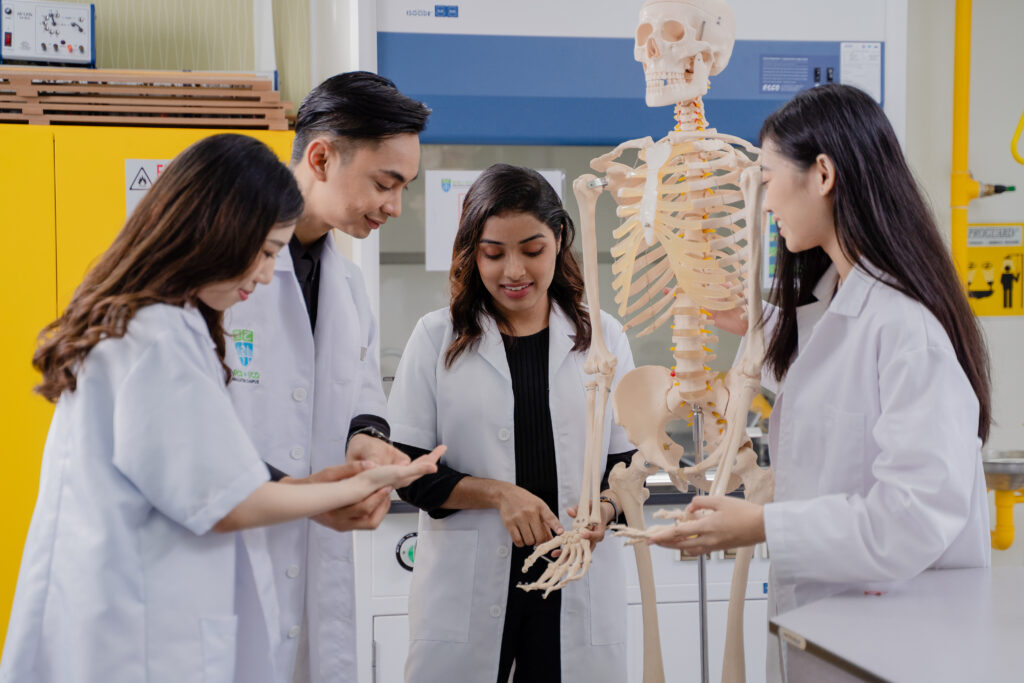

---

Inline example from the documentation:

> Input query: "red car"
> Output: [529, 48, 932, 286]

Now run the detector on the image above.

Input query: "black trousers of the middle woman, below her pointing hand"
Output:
[498, 546, 562, 683]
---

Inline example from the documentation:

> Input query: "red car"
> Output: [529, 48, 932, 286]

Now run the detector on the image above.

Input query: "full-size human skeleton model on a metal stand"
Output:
[522, 0, 773, 683]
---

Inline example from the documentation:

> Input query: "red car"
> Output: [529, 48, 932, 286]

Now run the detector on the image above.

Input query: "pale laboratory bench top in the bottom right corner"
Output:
[769, 567, 1024, 683]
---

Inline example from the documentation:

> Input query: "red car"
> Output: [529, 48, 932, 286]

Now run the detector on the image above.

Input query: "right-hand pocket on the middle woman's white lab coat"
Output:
[587, 532, 633, 645]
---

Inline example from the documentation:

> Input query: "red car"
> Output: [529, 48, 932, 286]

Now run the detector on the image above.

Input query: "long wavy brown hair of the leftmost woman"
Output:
[32, 133, 303, 401]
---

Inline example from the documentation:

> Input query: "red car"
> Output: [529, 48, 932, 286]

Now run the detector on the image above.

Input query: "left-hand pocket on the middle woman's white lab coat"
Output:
[409, 528, 478, 643]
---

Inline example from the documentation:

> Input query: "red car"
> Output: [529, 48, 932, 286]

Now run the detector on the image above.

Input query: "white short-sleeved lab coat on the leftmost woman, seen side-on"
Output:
[0, 304, 267, 683]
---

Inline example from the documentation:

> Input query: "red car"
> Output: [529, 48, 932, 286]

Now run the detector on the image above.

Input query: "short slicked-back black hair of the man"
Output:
[291, 71, 430, 165]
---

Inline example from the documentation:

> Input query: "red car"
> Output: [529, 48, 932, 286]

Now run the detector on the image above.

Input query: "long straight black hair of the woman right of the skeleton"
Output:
[761, 84, 991, 440]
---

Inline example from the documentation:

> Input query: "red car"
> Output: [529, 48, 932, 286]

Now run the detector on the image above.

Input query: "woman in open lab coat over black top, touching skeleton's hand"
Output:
[388, 164, 633, 683]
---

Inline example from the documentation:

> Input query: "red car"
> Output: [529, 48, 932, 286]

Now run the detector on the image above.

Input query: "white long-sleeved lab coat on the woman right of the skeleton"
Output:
[764, 265, 990, 675]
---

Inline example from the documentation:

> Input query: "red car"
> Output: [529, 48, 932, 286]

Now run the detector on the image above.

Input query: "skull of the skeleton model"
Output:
[633, 0, 736, 106]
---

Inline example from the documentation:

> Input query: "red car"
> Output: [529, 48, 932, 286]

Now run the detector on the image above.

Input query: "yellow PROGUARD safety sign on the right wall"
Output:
[967, 223, 1024, 315]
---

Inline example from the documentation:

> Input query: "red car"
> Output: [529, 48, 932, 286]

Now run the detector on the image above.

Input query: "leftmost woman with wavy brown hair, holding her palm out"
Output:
[0, 134, 436, 683]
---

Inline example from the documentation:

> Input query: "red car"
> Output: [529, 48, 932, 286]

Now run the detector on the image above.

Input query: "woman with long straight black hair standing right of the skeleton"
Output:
[652, 85, 991, 674]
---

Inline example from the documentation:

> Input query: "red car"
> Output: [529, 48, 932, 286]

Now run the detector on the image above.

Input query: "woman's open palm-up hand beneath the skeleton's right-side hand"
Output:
[648, 496, 765, 555]
